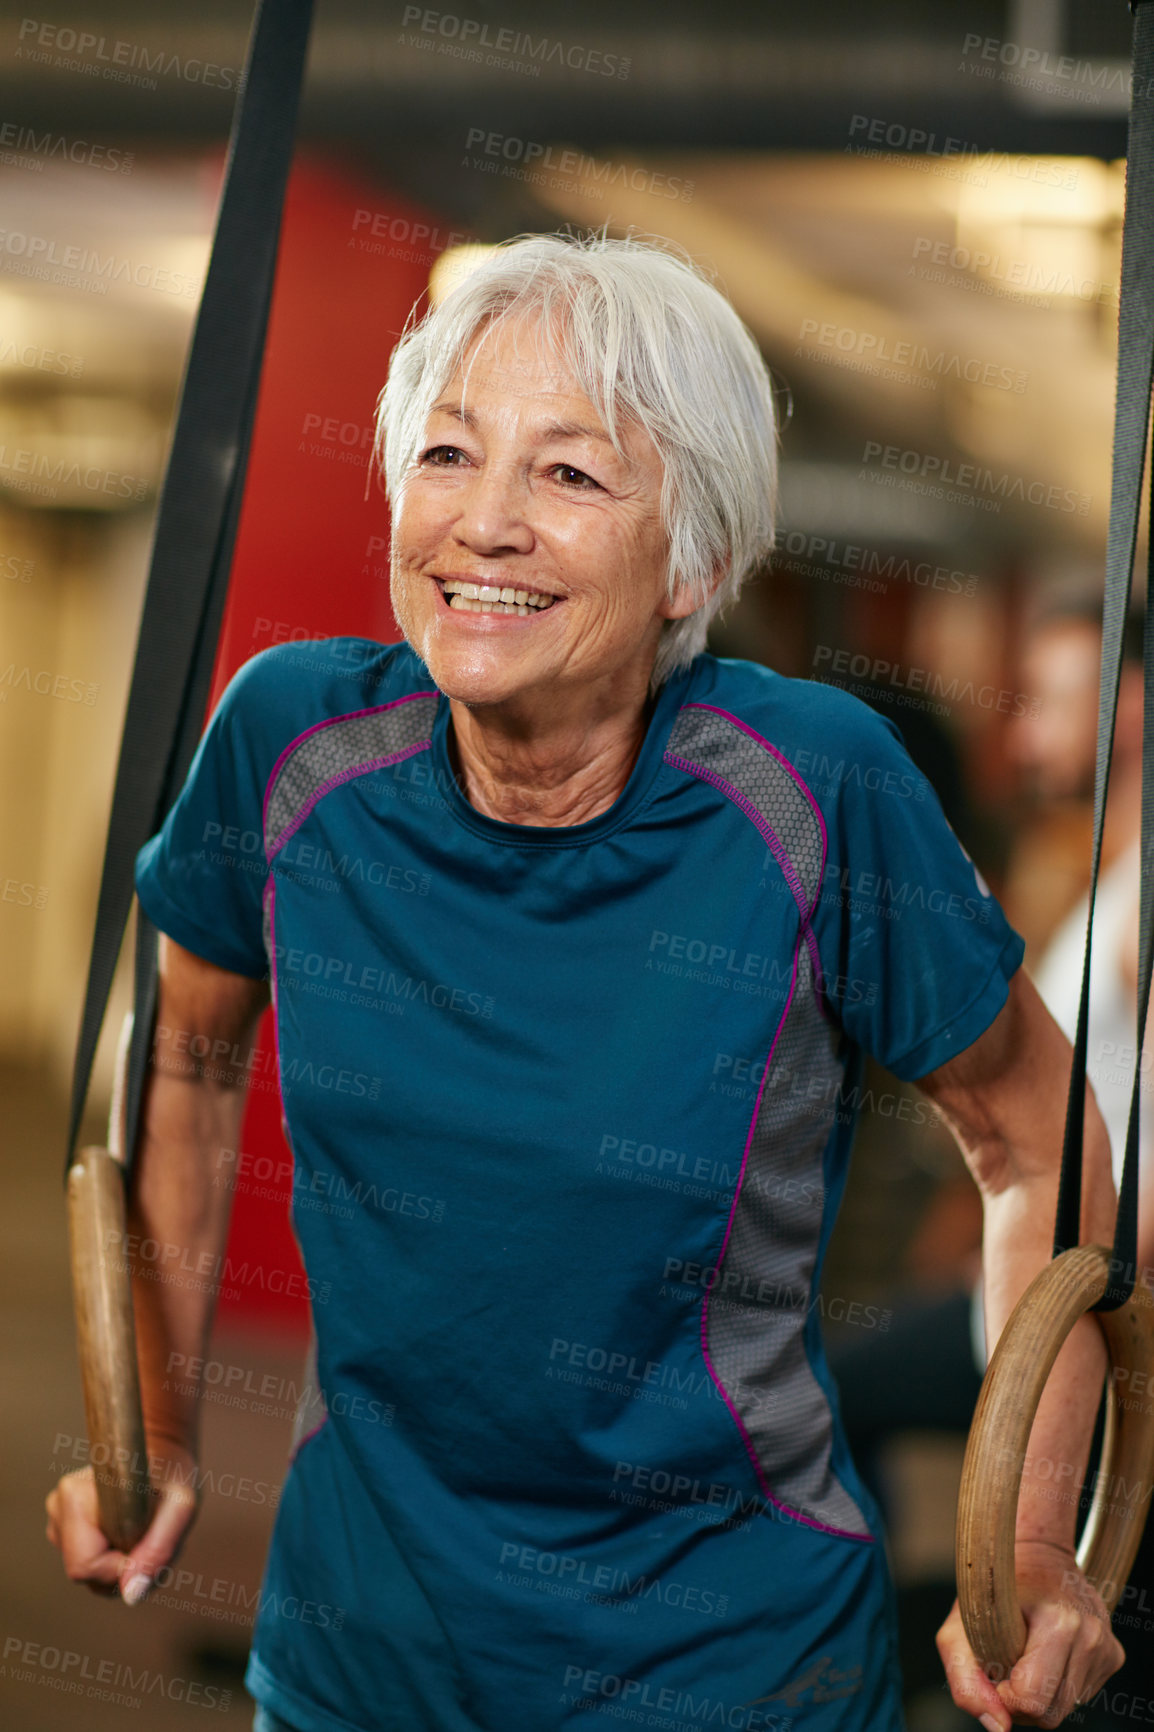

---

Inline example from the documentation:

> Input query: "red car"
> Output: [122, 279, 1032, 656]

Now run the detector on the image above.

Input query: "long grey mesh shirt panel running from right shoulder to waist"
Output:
[654, 705, 868, 1536]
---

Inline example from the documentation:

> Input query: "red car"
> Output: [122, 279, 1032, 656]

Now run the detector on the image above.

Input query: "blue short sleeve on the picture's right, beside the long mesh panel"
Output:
[813, 701, 1024, 1081]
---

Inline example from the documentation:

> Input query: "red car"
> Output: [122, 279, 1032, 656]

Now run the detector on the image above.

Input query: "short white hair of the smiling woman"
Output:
[374, 234, 778, 686]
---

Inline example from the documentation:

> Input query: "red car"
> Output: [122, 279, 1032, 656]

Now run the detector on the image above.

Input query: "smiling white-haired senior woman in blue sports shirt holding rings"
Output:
[50, 237, 1121, 1732]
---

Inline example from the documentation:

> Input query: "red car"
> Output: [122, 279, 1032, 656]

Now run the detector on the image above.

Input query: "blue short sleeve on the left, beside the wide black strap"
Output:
[135, 656, 274, 979]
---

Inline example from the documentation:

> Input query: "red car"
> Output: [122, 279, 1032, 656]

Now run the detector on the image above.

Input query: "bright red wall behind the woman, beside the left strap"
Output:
[211, 161, 441, 1330]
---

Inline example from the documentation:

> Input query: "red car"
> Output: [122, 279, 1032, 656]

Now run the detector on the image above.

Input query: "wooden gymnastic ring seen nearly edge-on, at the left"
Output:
[68, 1147, 152, 1552]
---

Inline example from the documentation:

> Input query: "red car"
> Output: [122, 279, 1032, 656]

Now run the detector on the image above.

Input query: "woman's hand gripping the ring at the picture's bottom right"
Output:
[937, 1540, 1126, 1732]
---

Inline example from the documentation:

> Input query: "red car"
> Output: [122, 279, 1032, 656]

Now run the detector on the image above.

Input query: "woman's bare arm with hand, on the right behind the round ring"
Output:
[918, 970, 1123, 1729]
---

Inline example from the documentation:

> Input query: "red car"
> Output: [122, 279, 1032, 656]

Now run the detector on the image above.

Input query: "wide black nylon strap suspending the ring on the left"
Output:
[68, 0, 312, 1162]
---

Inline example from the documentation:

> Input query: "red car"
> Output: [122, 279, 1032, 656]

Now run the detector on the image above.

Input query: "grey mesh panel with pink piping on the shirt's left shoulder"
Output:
[263, 691, 438, 998]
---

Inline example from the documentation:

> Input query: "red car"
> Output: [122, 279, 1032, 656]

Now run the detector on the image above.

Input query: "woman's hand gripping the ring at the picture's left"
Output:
[45, 1443, 199, 1606]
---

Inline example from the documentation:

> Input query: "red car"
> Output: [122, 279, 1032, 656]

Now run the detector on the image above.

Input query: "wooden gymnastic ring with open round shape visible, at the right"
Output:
[956, 1245, 1154, 1678]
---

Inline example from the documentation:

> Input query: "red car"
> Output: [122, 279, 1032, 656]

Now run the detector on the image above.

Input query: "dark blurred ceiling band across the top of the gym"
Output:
[0, 0, 1130, 155]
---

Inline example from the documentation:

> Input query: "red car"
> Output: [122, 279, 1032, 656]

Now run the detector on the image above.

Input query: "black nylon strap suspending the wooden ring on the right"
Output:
[1054, 0, 1154, 1311]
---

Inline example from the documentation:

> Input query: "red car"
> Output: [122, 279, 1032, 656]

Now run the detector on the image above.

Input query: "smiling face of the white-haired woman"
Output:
[392, 319, 695, 710]
